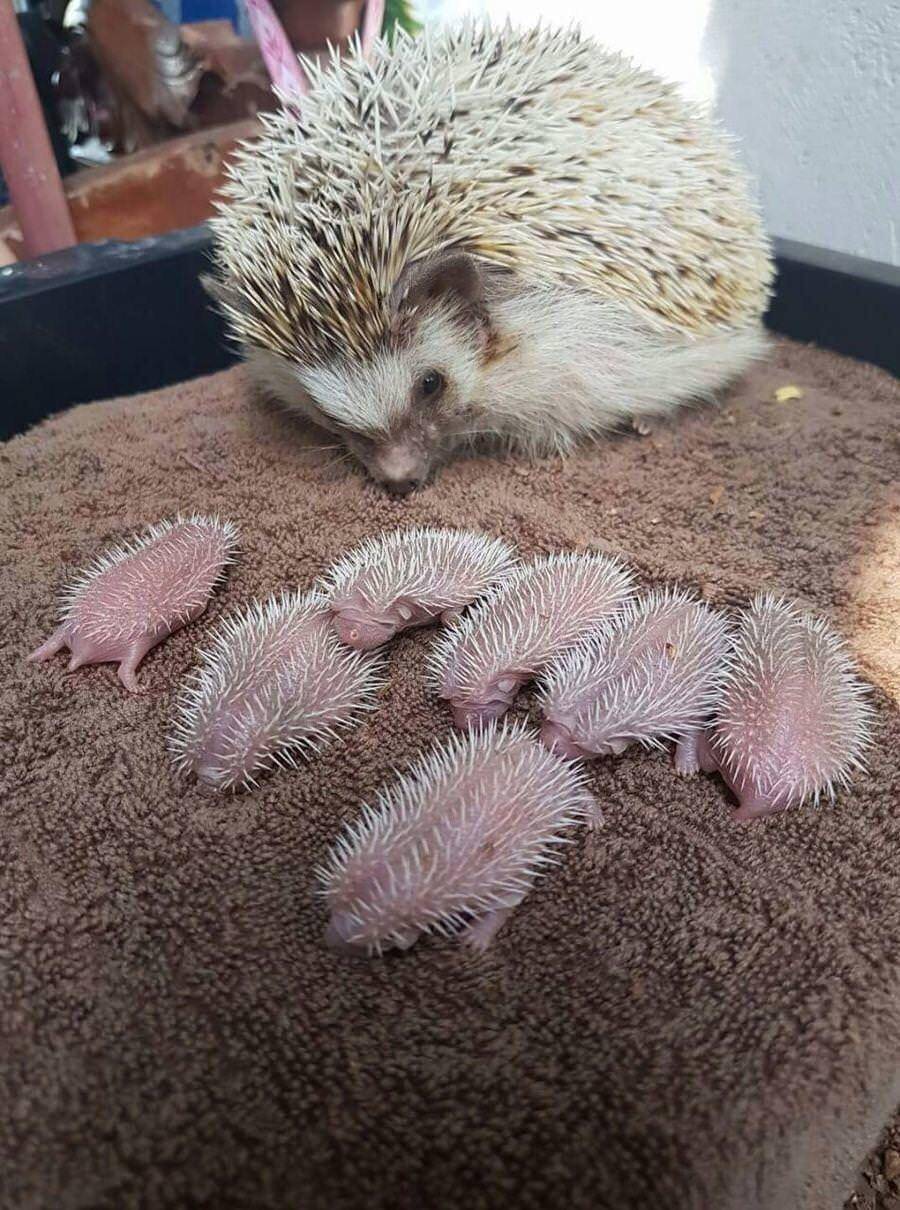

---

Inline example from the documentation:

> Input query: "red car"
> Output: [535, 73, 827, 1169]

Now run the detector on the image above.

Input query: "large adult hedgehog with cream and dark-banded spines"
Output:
[207, 22, 772, 494]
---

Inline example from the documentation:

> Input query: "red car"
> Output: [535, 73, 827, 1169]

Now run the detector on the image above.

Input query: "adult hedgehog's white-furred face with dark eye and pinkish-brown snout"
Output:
[254, 306, 481, 491]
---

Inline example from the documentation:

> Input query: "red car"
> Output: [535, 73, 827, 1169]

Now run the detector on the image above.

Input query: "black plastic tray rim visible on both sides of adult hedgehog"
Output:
[0, 225, 900, 439]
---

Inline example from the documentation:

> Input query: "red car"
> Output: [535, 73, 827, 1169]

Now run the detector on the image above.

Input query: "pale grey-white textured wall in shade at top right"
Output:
[702, 0, 900, 265]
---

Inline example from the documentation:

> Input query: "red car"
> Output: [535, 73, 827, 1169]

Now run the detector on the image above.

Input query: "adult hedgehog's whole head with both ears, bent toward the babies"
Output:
[207, 248, 494, 495]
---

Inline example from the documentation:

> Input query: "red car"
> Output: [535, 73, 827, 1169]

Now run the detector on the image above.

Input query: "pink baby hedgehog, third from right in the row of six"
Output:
[429, 554, 633, 727]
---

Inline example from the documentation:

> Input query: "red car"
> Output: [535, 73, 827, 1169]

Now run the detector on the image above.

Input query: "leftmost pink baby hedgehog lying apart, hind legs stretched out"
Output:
[28, 515, 237, 693]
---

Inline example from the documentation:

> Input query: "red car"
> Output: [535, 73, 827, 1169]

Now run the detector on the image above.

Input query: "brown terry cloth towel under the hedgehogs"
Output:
[0, 342, 900, 1210]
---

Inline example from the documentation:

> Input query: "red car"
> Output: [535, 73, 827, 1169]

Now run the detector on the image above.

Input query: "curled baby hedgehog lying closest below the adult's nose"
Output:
[322, 528, 515, 651]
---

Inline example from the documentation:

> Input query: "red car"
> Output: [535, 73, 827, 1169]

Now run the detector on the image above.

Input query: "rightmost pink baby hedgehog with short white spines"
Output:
[698, 595, 872, 820]
